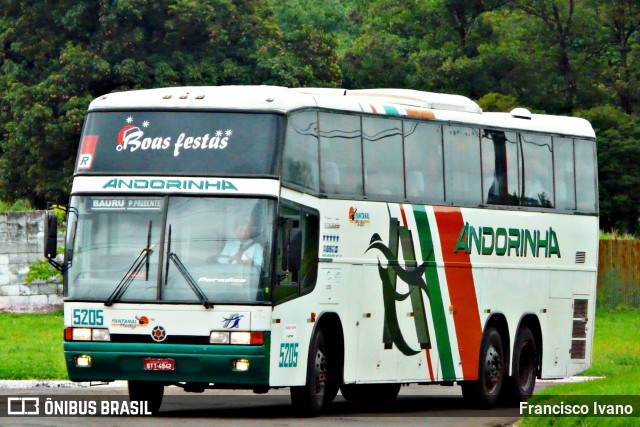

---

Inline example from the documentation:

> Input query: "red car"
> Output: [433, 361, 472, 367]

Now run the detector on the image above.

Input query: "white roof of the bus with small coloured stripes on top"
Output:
[89, 86, 595, 138]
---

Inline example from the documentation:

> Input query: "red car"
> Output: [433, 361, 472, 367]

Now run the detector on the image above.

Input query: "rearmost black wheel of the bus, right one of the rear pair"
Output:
[504, 326, 538, 406]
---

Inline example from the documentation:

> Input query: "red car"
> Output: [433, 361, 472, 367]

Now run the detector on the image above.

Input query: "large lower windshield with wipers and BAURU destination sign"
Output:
[66, 196, 275, 306]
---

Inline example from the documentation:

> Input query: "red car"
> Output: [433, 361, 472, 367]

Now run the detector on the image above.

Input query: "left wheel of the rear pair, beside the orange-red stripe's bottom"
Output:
[462, 326, 505, 409]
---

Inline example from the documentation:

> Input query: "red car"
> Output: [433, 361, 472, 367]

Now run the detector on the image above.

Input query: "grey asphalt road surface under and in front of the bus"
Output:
[0, 382, 551, 427]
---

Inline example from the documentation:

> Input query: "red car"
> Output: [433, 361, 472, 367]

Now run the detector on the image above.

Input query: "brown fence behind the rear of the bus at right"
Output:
[597, 240, 640, 308]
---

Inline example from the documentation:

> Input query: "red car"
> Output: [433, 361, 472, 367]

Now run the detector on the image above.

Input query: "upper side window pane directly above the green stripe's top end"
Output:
[403, 120, 444, 203]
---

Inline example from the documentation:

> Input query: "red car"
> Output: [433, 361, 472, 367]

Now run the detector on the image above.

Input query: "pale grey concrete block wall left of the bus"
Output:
[0, 211, 62, 313]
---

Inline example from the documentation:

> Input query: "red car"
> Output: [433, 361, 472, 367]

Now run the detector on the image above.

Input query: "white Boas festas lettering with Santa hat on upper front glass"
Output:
[116, 116, 233, 157]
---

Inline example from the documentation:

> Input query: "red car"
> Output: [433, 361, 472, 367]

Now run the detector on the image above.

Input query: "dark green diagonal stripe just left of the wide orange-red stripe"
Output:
[413, 206, 456, 380]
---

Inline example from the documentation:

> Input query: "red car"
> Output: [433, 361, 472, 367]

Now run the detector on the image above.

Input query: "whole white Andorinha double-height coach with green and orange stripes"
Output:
[46, 86, 598, 414]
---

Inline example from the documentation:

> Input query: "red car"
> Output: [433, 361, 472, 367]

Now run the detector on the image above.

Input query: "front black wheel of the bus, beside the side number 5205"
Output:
[291, 328, 339, 417]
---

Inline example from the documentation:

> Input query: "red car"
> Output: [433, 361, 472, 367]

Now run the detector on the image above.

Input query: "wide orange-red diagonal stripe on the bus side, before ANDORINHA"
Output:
[433, 207, 482, 380]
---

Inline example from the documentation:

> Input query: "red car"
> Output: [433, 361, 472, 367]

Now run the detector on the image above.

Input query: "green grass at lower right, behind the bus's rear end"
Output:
[519, 309, 640, 427]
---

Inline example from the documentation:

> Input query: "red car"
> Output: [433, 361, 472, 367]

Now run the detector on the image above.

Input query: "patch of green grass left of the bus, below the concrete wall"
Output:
[0, 311, 67, 380]
